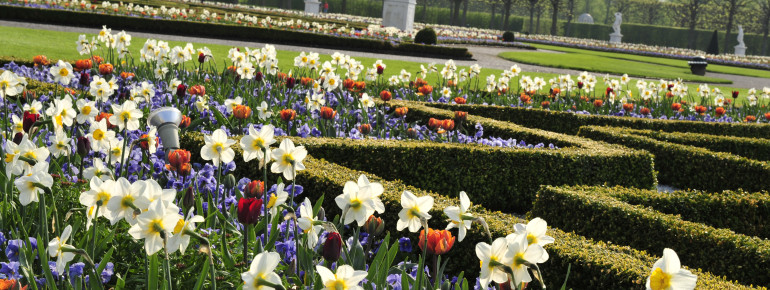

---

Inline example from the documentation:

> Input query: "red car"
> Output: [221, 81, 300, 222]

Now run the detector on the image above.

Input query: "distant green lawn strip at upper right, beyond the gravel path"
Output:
[533, 44, 770, 78]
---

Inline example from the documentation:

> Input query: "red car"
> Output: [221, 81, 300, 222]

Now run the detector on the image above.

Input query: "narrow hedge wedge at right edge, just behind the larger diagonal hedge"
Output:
[612, 130, 770, 161]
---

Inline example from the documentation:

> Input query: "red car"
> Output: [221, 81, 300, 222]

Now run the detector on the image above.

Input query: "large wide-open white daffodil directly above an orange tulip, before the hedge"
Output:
[334, 174, 385, 227]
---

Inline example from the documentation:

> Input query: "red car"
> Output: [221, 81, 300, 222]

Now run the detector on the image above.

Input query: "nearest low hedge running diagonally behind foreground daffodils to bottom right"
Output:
[297, 157, 751, 289]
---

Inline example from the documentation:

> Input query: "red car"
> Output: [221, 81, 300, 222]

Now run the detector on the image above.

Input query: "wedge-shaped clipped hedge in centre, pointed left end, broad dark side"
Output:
[181, 124, 655, 213]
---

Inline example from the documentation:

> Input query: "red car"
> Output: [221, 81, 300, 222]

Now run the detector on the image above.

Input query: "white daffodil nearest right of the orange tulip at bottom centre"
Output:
[476, 238, 513, 288]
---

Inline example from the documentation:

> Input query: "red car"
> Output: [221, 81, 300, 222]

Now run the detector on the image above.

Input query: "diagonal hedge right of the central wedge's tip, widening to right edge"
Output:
[578, 126, 770, 192]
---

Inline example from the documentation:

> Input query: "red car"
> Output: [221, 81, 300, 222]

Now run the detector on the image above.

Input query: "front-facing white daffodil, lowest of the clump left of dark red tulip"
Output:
[128, 200, 181, 256]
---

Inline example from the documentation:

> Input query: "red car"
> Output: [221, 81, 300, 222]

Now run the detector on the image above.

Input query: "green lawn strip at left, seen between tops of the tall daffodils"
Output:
[0, 26, 747, 103]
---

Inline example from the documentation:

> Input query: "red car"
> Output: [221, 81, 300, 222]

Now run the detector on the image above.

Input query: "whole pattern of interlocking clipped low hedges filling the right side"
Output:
[182, 101, 770, 289]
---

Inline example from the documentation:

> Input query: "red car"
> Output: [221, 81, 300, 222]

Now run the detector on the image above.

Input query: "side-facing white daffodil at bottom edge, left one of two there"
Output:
[241, 252, 282, 290]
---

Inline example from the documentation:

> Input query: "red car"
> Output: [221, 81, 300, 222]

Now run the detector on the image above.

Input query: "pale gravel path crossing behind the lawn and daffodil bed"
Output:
[0, 20, 770, 89]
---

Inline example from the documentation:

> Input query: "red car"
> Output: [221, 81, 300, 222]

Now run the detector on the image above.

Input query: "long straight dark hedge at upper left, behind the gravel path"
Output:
[0, 5, 472, 59]
